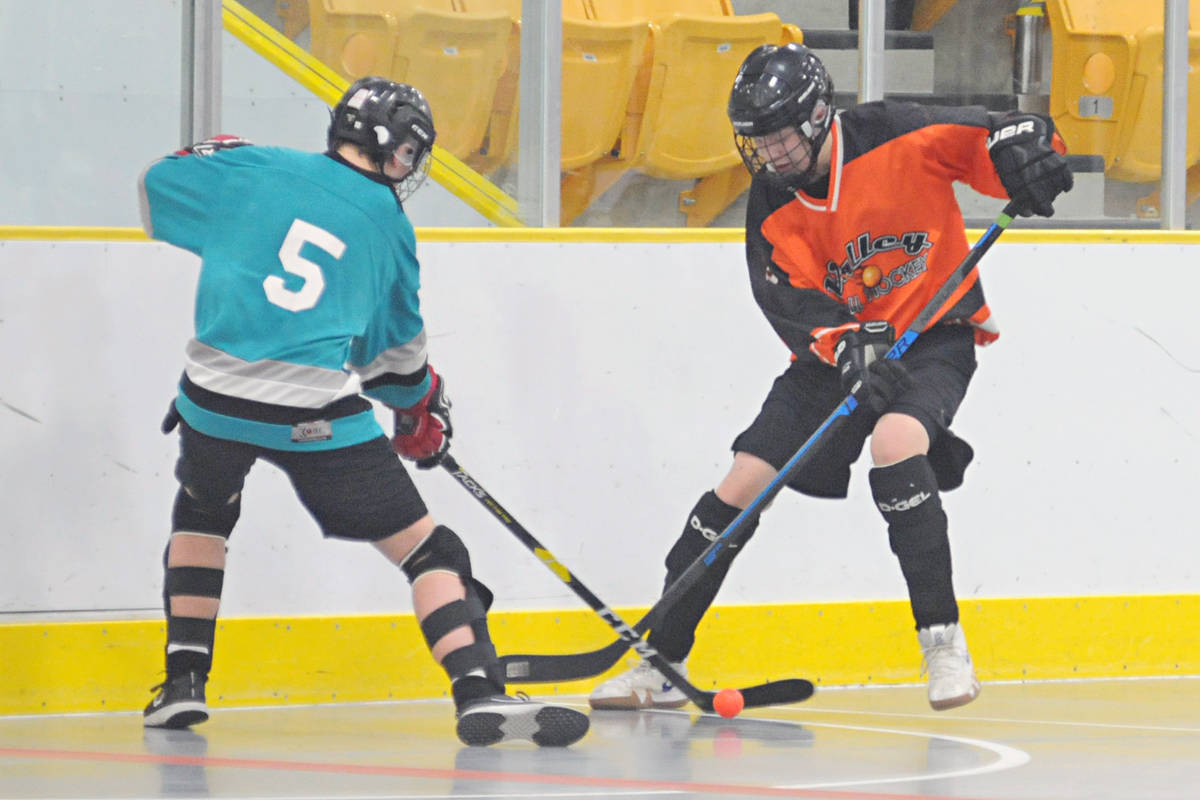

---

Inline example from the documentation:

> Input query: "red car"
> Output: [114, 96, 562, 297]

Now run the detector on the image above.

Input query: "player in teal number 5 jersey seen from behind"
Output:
[139, 77, 589, 747]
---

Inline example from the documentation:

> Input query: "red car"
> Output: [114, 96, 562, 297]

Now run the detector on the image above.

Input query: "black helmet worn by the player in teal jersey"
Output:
[328, 77, 437, 200]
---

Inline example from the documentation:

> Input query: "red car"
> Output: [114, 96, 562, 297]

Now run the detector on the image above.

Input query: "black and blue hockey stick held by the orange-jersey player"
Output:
[500, 203, 1016, 684]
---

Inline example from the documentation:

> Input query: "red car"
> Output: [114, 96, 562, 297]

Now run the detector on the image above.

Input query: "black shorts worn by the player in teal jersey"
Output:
[175, 420, 428, 541]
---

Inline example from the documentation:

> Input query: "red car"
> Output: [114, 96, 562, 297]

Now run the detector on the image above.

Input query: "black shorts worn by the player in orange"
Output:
[733, 325, 976, 498]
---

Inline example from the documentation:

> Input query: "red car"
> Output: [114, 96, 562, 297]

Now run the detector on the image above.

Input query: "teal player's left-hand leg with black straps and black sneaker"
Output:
[143, 423, 254, 728]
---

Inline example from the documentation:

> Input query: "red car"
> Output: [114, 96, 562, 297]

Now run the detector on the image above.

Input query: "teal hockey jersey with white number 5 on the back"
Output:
[142, 146, 430, 449]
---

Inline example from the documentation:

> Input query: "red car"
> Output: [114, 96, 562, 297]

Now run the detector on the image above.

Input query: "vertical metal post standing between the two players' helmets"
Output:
[517, 0, 563, 228]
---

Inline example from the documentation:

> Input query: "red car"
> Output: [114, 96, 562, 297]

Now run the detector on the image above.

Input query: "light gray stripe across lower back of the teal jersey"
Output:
[185, 339, 362, 408]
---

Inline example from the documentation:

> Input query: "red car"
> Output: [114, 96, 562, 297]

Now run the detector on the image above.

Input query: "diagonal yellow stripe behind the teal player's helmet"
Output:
[222, 0, 524, 227]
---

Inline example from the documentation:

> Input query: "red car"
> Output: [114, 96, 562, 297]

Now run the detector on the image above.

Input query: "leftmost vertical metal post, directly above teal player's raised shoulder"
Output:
[179, 0, 221, 146]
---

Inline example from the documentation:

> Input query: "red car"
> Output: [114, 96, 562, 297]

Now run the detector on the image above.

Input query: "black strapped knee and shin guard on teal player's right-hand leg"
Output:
[400, 525, 504, 686]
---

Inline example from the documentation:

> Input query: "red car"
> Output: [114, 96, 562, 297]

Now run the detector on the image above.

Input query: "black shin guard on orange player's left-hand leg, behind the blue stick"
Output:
[648, 492, 758, 661]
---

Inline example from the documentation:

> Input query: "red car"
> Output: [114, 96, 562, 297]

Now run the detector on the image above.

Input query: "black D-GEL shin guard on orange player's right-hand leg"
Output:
[870, 456, 959, 628]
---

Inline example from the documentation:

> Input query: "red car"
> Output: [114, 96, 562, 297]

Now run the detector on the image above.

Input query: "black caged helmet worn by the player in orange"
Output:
[727, 43, 834, 191]
